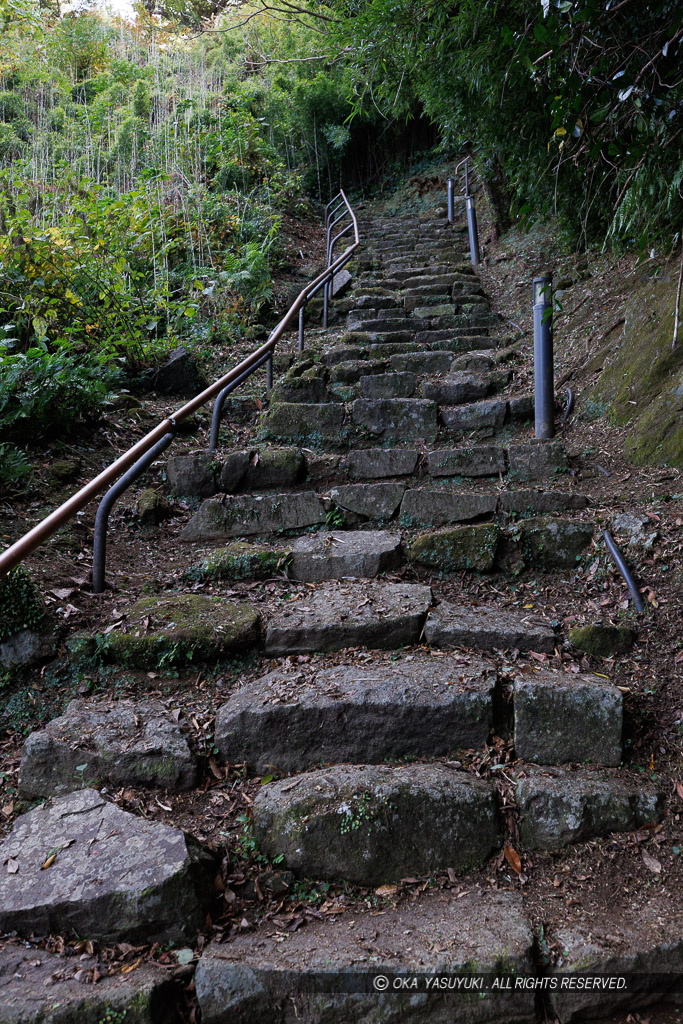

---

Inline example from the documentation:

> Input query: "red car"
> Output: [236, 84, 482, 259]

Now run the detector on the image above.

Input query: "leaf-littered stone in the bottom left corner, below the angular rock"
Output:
[0, 943, 177, 1024]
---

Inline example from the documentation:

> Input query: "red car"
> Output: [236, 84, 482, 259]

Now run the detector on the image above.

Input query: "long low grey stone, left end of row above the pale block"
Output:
[180, 490, 326, 541]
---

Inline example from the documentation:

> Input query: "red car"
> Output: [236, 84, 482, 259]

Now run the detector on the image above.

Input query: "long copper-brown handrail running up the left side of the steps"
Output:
[0, 189, 360, 577]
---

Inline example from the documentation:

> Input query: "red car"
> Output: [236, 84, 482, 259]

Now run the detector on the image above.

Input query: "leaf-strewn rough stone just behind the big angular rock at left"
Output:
[18, 700, 197, 800]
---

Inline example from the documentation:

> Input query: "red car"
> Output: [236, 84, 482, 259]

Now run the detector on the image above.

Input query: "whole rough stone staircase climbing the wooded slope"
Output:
[0, 201, 683, 1024]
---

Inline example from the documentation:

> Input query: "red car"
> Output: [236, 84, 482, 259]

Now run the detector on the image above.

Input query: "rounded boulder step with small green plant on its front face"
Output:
[254, 765, 501, 886]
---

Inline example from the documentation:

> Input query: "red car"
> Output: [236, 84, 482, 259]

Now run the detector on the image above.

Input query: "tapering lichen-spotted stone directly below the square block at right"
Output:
[515, 768, 665, 850]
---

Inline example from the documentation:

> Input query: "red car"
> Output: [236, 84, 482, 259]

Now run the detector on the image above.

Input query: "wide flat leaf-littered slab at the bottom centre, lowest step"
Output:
[195, 889, 537, 1024]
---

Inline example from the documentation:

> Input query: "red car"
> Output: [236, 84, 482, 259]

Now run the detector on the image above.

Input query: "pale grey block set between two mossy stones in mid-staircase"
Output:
[289, 530, 403, 583]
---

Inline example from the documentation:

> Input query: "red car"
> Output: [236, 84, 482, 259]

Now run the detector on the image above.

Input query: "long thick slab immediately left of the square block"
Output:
[215, 653, 496, 772]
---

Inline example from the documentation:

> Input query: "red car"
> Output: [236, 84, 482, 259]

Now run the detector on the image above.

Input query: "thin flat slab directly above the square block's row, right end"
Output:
[425, 601, 556, 655]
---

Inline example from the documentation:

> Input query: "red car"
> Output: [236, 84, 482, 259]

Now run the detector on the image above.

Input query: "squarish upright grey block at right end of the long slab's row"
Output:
[514, 672, 624, 766]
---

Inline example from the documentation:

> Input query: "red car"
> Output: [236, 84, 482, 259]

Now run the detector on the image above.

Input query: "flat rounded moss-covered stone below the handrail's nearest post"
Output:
[100, 594, 259, 669]
